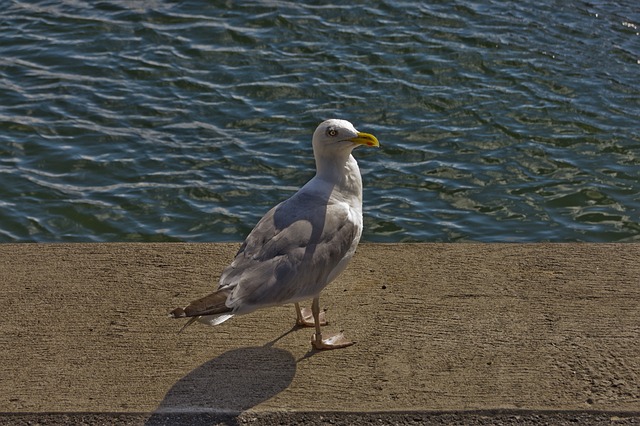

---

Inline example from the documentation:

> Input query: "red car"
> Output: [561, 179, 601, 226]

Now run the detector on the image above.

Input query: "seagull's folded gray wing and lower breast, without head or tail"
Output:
[220, 192, 362, 313]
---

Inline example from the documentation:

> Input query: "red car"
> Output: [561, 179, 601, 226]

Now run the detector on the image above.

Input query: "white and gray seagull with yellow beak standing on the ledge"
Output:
[169, 119, 380, 350]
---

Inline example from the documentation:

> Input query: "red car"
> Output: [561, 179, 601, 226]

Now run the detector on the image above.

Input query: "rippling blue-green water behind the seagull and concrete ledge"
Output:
[0, 0, 640, 242]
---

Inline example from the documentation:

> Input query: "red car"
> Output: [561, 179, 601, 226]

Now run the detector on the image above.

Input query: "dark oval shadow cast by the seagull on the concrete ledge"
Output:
[145, 344, 296, 426]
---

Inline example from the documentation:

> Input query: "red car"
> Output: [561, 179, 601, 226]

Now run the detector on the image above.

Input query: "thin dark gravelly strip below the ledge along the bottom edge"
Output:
[0, 410, 640, 426]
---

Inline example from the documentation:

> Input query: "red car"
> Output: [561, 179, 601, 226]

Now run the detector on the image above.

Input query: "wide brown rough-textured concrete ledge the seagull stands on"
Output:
[0, 243, 640, 424]
